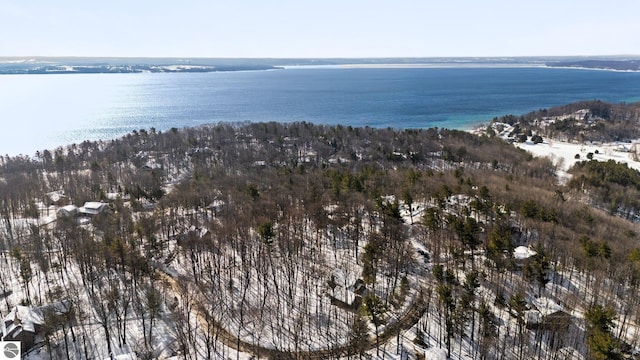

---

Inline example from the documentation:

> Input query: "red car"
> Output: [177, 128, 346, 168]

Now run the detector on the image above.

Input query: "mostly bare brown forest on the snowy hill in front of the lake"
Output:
[0, 116, 640, 359]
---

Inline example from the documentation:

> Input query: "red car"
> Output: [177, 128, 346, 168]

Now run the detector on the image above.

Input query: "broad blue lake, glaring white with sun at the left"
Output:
[0, 68, 640, 155]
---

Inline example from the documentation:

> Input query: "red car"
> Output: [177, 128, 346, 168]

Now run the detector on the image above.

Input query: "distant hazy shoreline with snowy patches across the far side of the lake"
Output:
[0, 56, 640, 75]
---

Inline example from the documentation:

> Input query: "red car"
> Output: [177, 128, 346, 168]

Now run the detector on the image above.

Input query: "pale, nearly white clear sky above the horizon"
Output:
[0, 0, 640, 58]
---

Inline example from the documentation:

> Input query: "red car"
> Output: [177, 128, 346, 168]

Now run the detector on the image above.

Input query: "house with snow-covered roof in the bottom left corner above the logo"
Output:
[2, 305, 44, 352]
